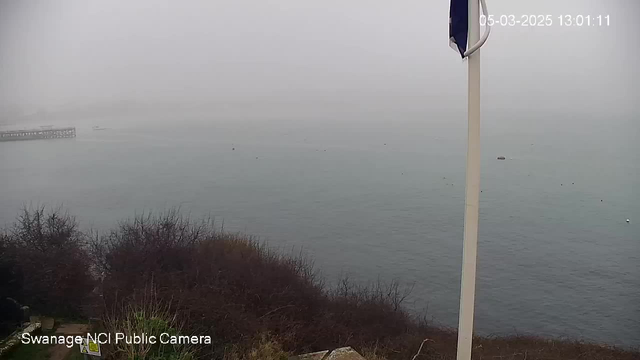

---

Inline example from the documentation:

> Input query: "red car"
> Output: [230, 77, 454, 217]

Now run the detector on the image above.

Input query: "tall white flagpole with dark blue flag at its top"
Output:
[457, 0, 480, 360]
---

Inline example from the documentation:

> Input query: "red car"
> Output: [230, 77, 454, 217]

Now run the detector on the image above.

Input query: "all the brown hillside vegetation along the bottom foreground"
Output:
[0, 208, 640, 360]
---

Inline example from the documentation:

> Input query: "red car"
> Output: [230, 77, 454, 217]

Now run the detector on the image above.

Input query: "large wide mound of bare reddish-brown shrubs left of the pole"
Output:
[92, 210, 424, 358]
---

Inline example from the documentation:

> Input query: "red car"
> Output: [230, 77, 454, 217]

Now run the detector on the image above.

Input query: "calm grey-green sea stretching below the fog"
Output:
[0, 114, 640, 346]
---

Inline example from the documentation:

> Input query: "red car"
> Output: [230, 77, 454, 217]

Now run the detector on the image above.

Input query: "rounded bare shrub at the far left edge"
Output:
[3, 206, 94, 316]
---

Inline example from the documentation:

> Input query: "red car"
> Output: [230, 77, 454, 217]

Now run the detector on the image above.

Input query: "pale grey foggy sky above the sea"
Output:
[0, 0, 640, 115]
